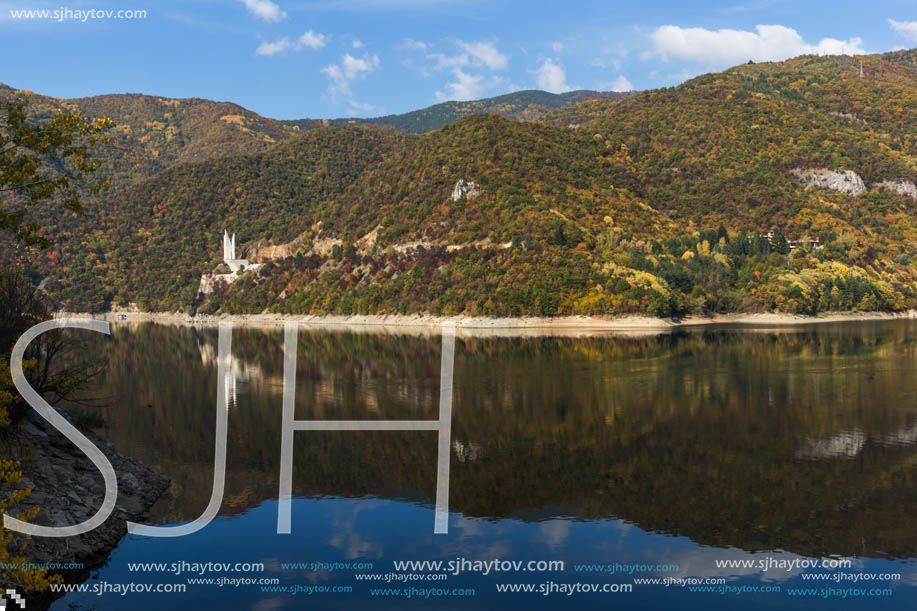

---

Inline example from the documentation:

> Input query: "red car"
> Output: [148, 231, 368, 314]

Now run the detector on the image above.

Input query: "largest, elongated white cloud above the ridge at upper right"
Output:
[650, 25, 866, 64]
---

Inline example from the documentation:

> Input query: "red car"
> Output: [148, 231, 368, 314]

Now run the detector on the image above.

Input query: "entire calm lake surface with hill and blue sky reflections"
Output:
[53, 322, 917, 611]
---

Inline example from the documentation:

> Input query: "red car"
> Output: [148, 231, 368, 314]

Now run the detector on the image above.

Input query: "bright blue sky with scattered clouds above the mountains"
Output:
[0, 0, 917, 119]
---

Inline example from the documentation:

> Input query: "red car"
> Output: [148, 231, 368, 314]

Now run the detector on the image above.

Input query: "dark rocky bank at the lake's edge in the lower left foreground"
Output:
[6, 409, 170, 609]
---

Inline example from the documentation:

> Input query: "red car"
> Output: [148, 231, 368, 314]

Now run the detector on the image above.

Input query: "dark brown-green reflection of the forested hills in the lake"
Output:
[68, 322, 917, 557]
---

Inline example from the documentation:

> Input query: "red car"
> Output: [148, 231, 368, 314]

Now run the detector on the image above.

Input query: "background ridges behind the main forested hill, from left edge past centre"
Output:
[0, 83, 632, 189]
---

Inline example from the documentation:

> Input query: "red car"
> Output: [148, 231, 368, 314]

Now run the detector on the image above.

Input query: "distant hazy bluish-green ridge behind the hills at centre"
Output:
[284, 90, 633, 134]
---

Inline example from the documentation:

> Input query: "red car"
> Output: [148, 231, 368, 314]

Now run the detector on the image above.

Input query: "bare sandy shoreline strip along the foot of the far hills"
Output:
[55, 310, 917, 336]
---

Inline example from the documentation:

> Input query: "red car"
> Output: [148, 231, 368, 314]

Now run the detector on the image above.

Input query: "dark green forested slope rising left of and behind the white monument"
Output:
[33, 128, 405, 309]
